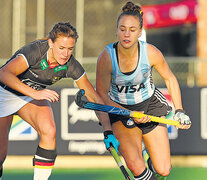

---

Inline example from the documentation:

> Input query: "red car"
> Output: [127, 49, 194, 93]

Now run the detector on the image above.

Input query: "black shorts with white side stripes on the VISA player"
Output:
[109, 88, 172, 134]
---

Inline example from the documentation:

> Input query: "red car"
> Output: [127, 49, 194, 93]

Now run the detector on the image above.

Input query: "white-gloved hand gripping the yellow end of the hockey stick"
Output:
[173, 109, 191, 129]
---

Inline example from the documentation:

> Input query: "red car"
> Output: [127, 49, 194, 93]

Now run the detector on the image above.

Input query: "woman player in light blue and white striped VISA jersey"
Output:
[96, 2, 191, 180]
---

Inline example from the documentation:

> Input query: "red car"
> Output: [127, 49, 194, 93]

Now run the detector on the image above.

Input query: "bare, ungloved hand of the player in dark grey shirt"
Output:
[32, 89, 60, 102]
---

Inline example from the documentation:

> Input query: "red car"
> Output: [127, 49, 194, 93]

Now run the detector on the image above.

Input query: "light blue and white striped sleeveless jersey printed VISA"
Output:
[106, 41, 155, 105]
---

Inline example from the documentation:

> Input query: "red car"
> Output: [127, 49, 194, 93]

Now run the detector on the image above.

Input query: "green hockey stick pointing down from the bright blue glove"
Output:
[108, 146, 131, 180]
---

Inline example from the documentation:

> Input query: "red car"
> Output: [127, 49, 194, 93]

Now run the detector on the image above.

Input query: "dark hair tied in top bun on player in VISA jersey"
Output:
[116, 1, 143, 29]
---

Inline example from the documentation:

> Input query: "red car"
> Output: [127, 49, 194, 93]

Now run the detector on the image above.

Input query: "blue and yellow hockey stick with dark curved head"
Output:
[75, 89, 180, 126]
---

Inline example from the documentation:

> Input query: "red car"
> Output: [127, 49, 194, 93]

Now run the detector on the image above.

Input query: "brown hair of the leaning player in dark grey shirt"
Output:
[48, 22, 78, 42]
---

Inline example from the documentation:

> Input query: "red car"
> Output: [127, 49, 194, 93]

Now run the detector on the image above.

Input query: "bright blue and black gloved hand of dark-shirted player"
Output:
[104, 130, 120, 152]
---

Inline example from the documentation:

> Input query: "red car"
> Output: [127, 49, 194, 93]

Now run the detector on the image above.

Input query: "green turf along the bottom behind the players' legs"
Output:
[3, 167, 207, 180]
